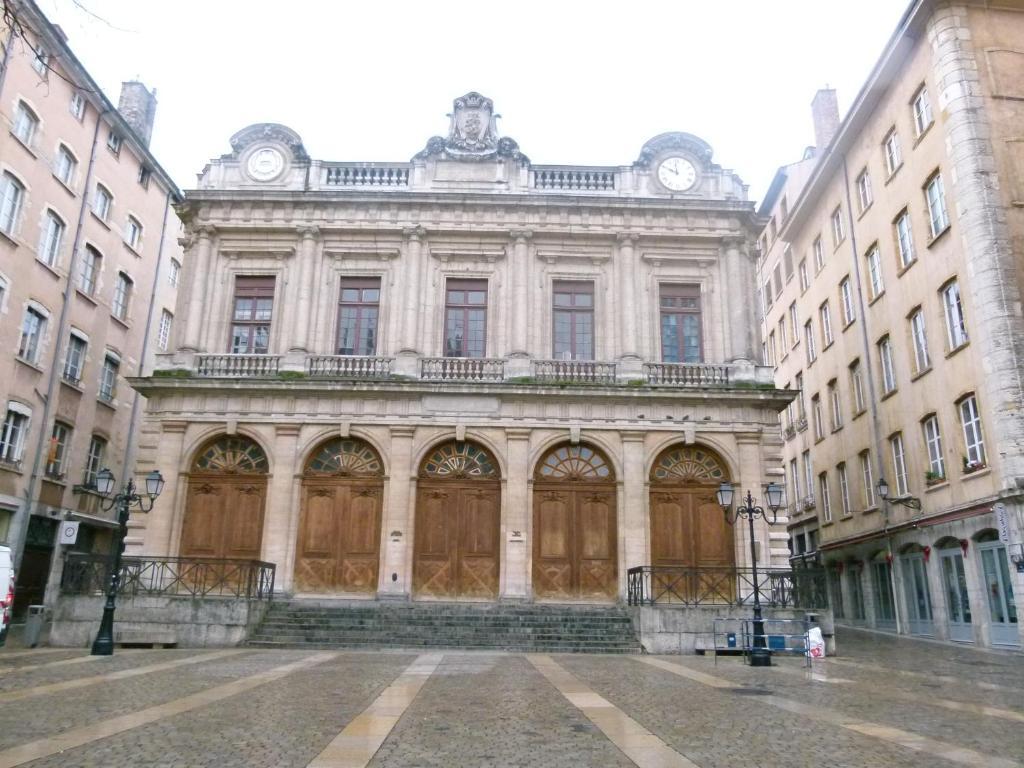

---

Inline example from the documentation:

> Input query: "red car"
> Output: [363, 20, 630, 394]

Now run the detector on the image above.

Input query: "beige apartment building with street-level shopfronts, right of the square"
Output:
[759, 1, 1024, 648]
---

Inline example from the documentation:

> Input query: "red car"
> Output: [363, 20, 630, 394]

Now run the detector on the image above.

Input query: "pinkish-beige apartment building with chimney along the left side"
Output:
[0, 0, 181, 610]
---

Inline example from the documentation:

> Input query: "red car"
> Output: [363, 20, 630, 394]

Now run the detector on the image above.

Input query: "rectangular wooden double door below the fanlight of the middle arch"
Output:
[413, 480, 501, 600]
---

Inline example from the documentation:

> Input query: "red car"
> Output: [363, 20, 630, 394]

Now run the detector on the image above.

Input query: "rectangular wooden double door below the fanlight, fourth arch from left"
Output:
[534, 483, 618, 601]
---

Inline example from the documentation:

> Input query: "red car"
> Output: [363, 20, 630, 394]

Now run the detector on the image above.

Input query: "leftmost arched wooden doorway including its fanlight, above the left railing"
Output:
[179, 435, 269, 560]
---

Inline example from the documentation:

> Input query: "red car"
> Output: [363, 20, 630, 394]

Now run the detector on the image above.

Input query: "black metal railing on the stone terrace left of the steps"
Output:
[60, 552, 276, 600]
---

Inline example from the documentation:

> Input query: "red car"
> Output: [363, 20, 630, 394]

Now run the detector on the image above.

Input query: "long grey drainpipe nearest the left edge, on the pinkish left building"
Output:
[11, 110, 110, 572]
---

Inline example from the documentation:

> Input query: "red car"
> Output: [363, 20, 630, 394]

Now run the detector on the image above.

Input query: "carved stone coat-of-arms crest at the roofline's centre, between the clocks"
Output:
[413, 91, 529, 163]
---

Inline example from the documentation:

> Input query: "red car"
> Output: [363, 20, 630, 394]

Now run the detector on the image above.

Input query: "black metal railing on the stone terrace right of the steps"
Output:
[627, 565, 828, 608]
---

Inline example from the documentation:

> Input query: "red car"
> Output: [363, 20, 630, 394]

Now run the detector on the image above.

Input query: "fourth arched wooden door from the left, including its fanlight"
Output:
[534, 445, 618, 600]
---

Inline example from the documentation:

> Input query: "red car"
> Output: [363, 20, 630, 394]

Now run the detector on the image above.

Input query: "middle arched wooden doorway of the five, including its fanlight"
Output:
[413, 440, 501, 600]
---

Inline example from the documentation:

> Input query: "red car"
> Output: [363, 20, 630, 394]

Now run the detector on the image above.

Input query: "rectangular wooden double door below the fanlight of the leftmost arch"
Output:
[179, 475, 266, 560]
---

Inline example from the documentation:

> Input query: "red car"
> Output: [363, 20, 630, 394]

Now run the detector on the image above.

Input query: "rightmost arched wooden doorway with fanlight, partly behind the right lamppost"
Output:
[650, 445, 736, 568]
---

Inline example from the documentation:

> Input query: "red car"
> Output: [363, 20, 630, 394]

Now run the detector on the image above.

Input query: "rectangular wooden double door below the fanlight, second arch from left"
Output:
[295, 478, 383, 593]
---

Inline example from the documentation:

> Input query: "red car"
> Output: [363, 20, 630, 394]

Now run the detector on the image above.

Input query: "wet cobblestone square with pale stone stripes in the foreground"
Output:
[0, 630, 1024, 768]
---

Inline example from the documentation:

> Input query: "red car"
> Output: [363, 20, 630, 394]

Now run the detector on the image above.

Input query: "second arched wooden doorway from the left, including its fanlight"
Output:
[295, 437, 384, 593]
